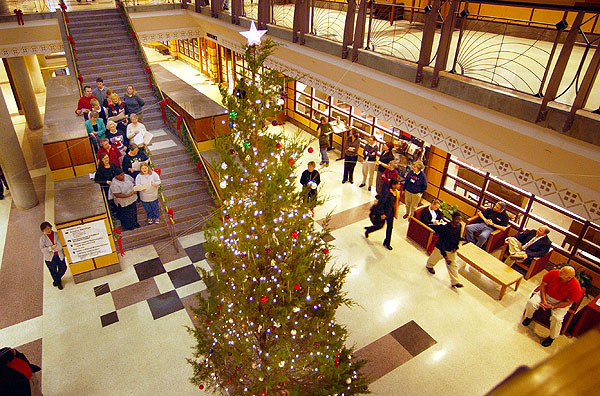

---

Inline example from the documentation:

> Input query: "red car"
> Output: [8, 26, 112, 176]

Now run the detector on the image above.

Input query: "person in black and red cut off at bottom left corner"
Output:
[0, 347, 42, 396]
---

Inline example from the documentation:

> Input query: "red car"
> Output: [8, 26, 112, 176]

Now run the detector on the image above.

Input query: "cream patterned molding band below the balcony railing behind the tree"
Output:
[222, 40, 600, 222]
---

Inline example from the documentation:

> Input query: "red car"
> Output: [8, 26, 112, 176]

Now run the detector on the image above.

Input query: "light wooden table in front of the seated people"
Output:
[456, 243, 523, 300]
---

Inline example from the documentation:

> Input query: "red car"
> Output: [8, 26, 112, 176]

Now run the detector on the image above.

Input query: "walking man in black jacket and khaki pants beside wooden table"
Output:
[426, 212, 463, 288]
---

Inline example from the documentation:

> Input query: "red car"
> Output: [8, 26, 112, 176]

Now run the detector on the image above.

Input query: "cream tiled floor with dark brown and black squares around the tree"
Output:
[0, 53, 584, 396]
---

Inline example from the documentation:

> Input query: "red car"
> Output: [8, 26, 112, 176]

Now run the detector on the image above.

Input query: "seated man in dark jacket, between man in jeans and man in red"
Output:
[504, 226, 552, 265]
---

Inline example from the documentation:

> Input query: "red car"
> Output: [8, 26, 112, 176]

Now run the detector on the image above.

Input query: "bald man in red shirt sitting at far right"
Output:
[522, 266, 582, 347]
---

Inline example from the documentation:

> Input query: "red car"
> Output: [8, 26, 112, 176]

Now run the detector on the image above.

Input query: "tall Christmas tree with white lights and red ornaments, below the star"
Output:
[189, 27, 368, 396]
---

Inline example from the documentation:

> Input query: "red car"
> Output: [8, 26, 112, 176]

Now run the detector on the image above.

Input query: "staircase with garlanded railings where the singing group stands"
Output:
[69, 9, 213, 250]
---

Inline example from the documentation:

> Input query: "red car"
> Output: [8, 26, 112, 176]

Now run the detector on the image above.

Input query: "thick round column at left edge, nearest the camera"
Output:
[0, 88, 39, 209]
